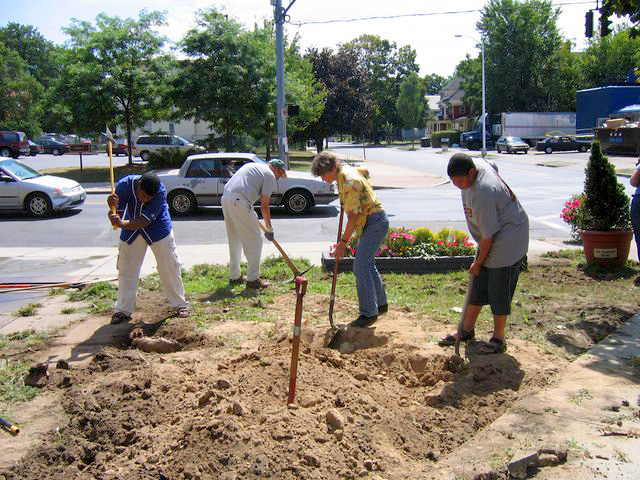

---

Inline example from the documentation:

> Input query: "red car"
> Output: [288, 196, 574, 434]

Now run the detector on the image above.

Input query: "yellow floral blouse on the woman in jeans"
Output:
[337, 165, 382, 235]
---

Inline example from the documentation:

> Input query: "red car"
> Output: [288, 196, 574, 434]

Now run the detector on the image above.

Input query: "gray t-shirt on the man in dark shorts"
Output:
[461, 159, 529, 268]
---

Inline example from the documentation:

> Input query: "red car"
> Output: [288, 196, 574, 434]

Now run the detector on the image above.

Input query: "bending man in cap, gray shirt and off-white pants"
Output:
[222, 159, 287, 288]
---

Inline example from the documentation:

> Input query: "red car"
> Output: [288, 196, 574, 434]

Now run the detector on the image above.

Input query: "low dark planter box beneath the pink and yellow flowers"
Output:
[321, 252, 473, 273]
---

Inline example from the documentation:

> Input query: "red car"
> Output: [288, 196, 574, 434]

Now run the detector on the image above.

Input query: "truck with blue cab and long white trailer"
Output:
[460, 112, 576, 150]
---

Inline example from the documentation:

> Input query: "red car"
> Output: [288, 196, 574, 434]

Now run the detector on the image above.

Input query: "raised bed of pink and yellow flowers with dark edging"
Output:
[322, 228, 475, 273]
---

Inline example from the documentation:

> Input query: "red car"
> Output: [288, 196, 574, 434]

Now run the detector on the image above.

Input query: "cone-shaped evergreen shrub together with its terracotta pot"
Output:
[579, 140, 633, 265]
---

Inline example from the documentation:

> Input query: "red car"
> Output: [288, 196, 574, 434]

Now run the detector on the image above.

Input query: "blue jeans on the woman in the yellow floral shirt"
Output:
[353, 211, 389, 317]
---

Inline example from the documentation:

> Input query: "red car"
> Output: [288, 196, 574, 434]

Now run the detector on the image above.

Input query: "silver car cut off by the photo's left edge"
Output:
[0, 159, 87, 217]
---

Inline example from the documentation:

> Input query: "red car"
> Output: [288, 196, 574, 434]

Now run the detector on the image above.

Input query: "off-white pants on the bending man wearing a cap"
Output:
[222, 194, 262, 282]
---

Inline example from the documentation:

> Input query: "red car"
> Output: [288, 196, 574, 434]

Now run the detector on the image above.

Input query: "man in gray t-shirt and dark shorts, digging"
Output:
[440, 153, 529, 353]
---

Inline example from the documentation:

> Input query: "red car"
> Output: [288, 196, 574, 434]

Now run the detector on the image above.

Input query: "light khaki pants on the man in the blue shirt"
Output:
[115, 230, 189, 315]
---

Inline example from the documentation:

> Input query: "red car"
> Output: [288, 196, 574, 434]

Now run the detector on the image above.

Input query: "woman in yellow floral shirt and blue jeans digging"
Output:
[311, 152, 389, 328]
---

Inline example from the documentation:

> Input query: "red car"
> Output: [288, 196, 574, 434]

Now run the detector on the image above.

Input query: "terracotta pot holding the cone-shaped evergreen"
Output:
[578, 230, 633, 266]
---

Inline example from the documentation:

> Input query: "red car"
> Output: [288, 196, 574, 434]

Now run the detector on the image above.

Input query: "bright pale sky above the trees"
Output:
[0, 0, 616, 77]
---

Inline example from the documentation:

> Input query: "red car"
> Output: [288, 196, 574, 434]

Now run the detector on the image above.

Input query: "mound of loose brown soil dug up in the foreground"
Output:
[0, 259, 638, 480]
